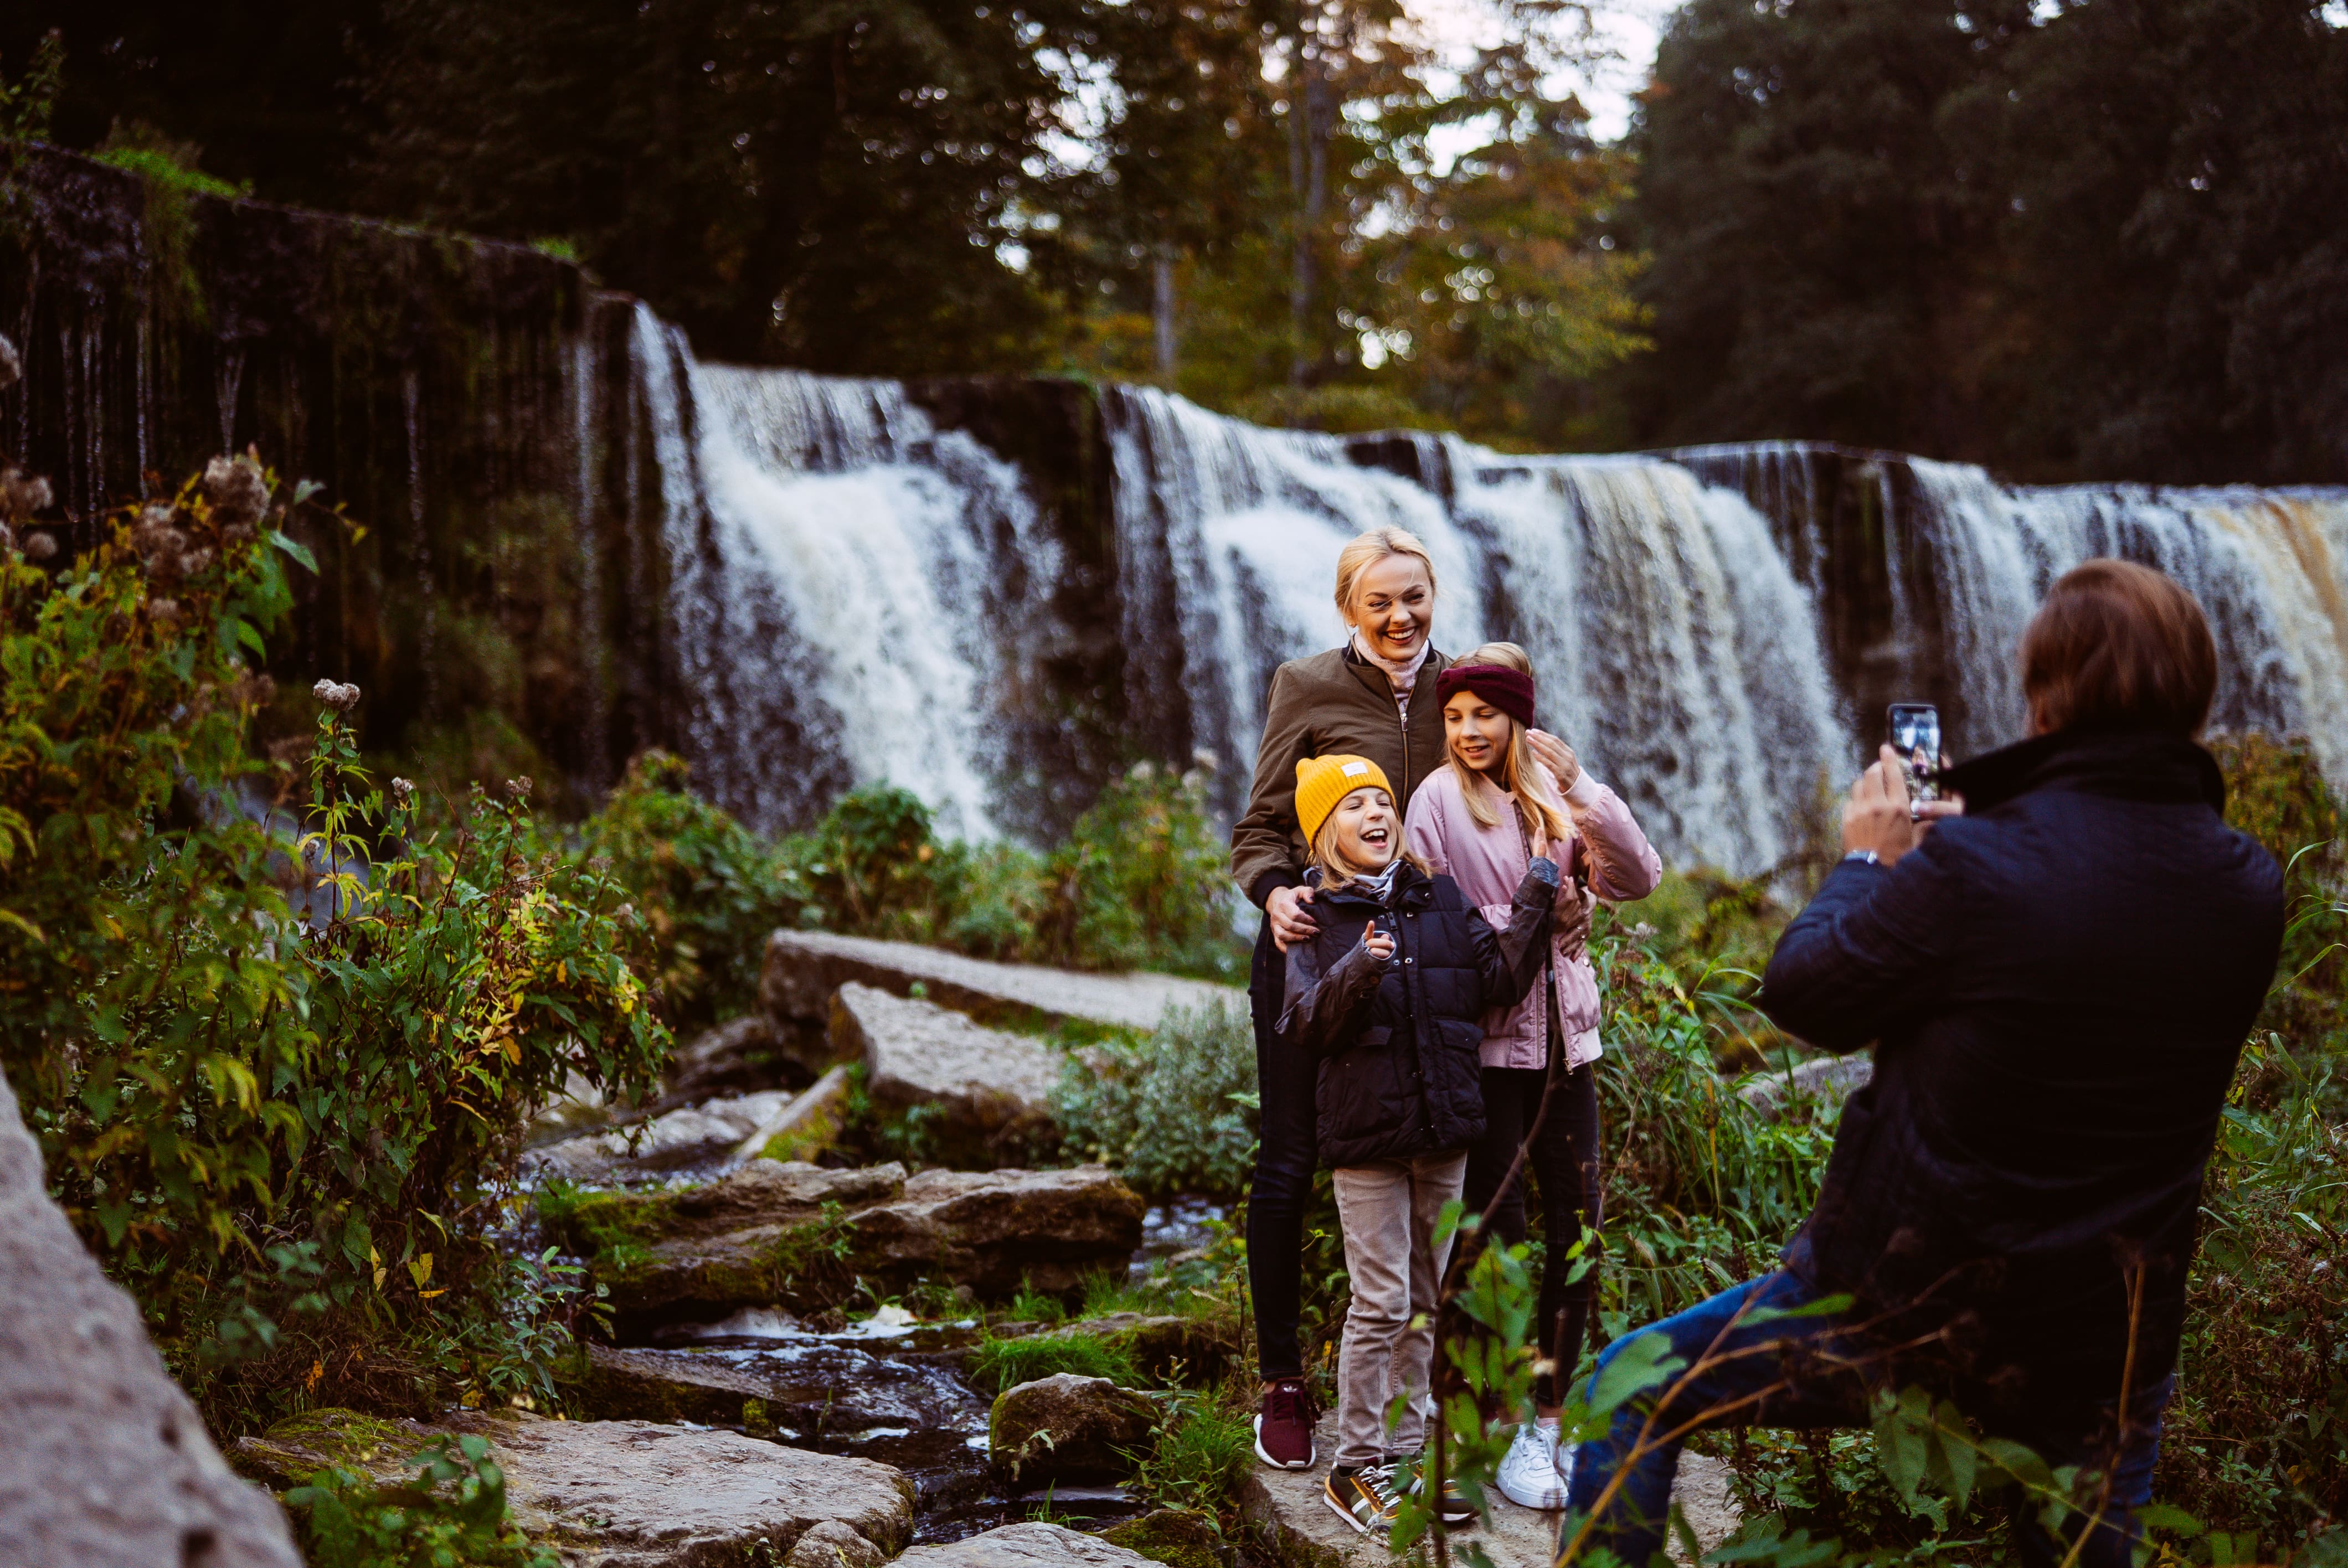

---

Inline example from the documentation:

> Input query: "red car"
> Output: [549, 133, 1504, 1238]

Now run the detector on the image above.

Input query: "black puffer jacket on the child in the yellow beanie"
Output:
[1280, 859, 1557, 1167]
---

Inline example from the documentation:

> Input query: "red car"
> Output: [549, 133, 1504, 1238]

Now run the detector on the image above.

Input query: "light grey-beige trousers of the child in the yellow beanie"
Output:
[1336, 1153, 1468, 1469]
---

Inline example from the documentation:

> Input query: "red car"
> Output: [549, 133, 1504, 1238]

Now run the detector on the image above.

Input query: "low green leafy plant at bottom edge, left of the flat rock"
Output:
[286, 1434, 561, 1568]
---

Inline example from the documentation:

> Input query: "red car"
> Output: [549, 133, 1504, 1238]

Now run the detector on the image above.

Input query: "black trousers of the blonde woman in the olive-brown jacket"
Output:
[1247, 918, 1324, 1383]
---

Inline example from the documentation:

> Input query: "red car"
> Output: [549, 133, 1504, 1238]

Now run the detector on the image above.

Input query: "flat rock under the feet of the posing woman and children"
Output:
[1240, 1413, 1740, 1568]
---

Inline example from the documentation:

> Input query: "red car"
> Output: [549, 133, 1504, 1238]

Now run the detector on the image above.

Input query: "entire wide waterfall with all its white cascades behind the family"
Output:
[632, 328, 2348, 873]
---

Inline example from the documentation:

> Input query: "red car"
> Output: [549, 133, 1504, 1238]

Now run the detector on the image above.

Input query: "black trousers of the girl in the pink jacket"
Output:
[1463, 1064, 1604, 1404]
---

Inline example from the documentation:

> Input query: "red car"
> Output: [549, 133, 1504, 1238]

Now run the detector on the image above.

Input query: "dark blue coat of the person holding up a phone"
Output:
[1759, 733, 2282, 1409]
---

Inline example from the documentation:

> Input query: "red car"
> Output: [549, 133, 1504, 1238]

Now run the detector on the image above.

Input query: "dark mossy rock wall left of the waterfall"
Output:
[0, 148, 674, 796]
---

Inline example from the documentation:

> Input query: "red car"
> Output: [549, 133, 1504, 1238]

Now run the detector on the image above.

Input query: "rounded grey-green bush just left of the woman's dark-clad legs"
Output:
[1052, 1002, 1256, 1195]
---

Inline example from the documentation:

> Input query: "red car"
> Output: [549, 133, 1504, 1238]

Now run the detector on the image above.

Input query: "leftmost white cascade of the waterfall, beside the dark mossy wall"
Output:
[639, 317, 1059, 838]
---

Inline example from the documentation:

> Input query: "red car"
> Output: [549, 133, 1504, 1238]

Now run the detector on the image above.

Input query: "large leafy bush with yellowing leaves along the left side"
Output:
[0, 460, 667, 1425]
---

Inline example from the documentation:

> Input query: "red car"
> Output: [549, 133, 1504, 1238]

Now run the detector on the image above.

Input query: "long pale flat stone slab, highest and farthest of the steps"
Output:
[759, 932, 1247, 1030]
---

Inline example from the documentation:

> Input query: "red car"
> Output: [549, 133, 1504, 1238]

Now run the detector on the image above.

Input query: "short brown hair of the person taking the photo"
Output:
[2022, 561, 2217, 737]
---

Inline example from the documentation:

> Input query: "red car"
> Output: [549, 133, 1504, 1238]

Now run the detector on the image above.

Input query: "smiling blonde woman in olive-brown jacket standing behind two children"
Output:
[1230, 528, 1444, 1469]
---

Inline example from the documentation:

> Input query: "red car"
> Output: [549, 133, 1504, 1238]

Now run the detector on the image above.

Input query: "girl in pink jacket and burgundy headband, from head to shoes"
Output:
[1404, 643, 1662, 1509]
